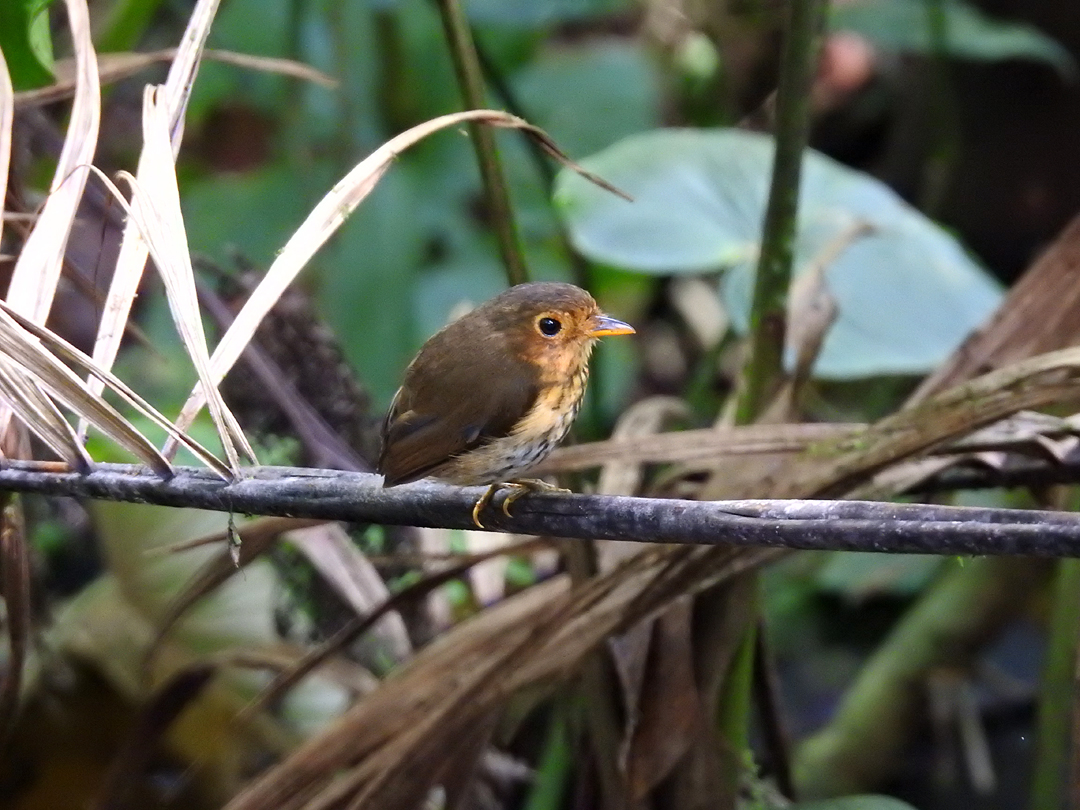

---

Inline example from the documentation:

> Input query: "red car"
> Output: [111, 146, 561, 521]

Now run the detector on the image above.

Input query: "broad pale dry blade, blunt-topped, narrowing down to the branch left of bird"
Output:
[121, 87, 255, 474]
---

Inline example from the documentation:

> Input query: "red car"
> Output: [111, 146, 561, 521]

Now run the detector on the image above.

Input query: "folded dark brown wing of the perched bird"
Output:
[379, 354, 538, 486]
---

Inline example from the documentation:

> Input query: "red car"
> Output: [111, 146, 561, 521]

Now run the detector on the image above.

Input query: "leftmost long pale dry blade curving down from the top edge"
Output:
[3, 0, 100, 326]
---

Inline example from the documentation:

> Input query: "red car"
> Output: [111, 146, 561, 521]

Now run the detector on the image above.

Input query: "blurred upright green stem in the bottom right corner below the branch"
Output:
[1028, 559, 1080, 810]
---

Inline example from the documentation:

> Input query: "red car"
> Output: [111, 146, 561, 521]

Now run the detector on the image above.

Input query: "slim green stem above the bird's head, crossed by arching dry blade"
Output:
[438, 0, 528, 284]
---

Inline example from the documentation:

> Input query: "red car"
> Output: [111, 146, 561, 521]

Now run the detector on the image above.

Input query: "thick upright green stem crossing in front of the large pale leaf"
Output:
[735, 0, 827, 424]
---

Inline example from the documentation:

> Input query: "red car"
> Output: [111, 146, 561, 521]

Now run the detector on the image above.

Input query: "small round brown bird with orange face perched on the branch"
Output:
[378, 282, 634, 528]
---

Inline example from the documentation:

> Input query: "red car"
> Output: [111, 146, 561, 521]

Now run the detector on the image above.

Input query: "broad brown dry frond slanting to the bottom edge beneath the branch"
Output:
[228, 546, 777, 810]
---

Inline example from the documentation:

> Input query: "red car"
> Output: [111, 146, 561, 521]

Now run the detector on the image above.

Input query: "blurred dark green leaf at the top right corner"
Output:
[829, 0, 1077, 75]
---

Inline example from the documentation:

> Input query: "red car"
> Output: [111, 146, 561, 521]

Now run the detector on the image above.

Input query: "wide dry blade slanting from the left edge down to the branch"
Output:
[0, 308, 172, 475]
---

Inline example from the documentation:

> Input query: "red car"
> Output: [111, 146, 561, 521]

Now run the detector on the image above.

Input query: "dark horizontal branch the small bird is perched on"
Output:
[6, 461, 1080, 556]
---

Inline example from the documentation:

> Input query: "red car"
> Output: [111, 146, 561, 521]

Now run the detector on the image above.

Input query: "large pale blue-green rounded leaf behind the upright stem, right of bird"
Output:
[555, 130, 1000, 379]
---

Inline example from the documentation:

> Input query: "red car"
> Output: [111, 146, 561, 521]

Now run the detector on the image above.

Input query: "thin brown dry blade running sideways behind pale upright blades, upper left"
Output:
[15, 48, 338, 107]
